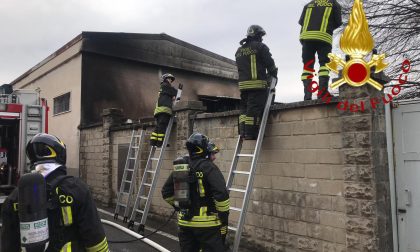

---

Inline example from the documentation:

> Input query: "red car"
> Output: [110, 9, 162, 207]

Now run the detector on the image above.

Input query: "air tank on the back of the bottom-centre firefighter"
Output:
[172, 156, 191, 209]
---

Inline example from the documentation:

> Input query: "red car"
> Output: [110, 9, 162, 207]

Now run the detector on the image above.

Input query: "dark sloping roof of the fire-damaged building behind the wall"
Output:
[11, 31, 238, 85]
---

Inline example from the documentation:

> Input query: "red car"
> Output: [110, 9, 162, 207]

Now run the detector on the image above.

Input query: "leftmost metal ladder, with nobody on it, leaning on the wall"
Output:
[114, 126, 146, 222]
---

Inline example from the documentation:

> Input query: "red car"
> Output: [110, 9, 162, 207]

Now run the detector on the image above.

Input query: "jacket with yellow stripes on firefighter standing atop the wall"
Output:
[299, 0, 342, 44]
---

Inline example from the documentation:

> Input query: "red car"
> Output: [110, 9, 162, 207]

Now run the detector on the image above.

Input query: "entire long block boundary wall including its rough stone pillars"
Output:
[81, 101, 389, 251]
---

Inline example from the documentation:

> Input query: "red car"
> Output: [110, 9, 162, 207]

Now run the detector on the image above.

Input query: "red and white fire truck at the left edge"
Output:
[0, 84, 48, 200]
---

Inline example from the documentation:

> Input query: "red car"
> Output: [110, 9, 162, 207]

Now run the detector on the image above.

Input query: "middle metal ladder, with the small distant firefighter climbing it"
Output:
[128, 84, 182, 234]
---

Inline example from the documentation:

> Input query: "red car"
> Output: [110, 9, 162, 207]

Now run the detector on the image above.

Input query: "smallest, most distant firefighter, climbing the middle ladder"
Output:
[150, 73, 178, 147]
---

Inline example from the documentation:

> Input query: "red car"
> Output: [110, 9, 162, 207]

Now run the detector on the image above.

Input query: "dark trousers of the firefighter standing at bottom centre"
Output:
[178, 226, 225, 252]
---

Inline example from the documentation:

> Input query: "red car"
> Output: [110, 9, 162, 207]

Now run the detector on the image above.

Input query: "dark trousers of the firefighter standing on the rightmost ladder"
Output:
[239, 89, 268, 139]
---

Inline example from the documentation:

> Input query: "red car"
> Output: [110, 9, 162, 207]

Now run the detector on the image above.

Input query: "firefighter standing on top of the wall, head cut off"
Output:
[299, 0, 342, 100]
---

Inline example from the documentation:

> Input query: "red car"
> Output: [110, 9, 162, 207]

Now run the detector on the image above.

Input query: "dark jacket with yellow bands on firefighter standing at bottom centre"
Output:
[162, 158, 229, 228]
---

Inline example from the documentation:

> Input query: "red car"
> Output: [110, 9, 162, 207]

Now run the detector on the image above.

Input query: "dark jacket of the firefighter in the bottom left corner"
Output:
[1, 167, 109, 252]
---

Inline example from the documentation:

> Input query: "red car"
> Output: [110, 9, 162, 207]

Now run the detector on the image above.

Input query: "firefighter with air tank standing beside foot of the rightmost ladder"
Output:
[162, 133, 229, 252]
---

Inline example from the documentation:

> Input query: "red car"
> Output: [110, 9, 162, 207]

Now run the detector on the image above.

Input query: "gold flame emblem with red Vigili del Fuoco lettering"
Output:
[304, 0, 411, 112]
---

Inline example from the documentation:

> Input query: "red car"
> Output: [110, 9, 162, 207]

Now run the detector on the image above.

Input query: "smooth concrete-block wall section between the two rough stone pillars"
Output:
[194, 104, 346, 251]
